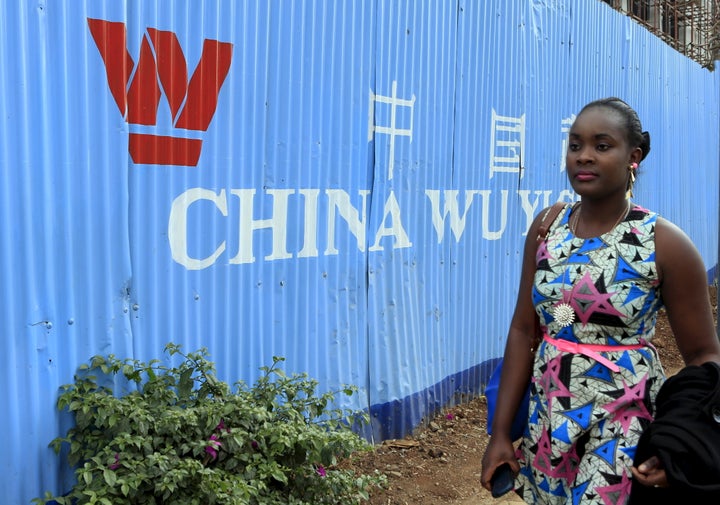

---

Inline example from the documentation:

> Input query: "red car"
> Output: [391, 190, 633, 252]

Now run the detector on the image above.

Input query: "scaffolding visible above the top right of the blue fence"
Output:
[602, 0, 720, 70]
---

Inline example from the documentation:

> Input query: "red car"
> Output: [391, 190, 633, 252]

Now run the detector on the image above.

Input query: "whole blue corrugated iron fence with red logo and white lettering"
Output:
[0, 0, 720, 504]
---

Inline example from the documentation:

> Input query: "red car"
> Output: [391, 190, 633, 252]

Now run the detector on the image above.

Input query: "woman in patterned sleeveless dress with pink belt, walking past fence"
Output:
[481, 98, 720, 504]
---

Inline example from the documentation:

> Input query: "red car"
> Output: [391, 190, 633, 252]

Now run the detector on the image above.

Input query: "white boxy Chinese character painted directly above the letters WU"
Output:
[490, 109, 525, 179]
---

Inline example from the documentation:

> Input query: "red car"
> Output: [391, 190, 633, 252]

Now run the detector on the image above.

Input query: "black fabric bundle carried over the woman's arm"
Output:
[630, 362, 720, 504]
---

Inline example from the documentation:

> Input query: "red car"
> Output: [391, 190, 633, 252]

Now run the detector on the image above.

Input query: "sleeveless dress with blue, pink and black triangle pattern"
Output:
[515, 204, 665, 505]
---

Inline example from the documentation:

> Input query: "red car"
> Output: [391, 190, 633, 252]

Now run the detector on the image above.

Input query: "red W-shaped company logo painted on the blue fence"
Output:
[88, 18, 232, 166]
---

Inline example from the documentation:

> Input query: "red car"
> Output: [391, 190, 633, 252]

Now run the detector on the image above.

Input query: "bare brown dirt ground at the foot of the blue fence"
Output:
[345, 288, 717, 505]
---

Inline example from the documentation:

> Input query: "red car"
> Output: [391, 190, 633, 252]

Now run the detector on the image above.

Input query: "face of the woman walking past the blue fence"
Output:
[565, 106, 641, 198]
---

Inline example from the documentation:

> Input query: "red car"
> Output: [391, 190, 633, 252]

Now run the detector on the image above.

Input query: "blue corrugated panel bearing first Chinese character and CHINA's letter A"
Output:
[368, 0, 457, 436]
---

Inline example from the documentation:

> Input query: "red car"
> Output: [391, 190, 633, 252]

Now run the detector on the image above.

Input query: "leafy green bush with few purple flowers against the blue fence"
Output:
[33, 344, 385, 505]
